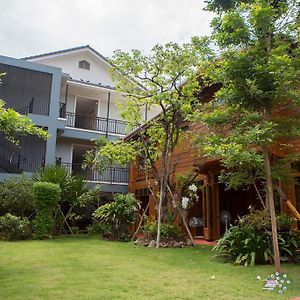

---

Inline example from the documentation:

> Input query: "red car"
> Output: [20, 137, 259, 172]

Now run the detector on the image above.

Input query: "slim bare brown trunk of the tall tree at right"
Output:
[262, 146, 280, 273]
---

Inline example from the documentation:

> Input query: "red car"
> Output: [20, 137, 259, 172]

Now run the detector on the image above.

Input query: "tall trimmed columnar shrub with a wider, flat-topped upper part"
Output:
[33, 182, 61, 238]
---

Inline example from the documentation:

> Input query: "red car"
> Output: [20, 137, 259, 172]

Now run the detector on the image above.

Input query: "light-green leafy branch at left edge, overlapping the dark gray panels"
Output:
[0, 100, 48, 143]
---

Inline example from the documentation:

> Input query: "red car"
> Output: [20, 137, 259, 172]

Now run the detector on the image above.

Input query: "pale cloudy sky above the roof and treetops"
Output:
[0, 0, 213, 58]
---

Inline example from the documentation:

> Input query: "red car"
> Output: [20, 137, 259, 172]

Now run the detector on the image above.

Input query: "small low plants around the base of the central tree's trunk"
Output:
[143, 220, 179, 239]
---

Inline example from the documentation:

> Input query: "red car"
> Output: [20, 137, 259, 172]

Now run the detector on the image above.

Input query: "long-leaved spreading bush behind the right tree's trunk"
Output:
[213, 211, 300, 266]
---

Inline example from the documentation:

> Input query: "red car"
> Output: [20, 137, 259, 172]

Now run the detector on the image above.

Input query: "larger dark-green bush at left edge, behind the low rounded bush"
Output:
[0, 175, 35, 217]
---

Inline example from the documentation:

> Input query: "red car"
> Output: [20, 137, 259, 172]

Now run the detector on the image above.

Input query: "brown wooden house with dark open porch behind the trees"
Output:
[126, 86, 300, 240]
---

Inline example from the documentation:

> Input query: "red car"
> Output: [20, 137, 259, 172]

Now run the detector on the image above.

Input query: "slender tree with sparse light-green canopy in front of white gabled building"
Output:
[83, 39, 206, 247]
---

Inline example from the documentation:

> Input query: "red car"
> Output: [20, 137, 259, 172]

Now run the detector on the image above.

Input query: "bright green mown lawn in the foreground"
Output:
[0, 236, 300, 300]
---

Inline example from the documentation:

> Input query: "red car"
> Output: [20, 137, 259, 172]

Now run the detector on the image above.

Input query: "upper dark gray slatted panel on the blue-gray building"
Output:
[0, 64, 52, 115]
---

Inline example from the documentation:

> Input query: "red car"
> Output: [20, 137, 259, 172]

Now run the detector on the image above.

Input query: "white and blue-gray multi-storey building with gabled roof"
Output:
[0, 45, 159, 193]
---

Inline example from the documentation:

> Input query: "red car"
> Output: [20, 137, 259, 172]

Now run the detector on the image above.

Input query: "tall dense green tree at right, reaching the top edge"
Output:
[194, 0, 300, 272]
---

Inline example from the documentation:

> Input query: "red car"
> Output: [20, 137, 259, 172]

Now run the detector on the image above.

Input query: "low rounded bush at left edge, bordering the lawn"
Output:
[0, 213, 30, 241]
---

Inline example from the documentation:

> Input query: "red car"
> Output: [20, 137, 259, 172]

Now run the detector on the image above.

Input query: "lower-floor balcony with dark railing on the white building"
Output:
[60, 162, 129, 184]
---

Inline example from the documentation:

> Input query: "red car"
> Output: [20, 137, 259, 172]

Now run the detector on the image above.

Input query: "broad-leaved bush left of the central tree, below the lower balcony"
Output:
[93, 194, 139, 240]
